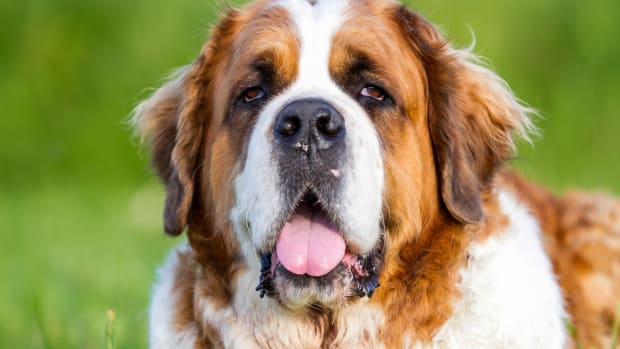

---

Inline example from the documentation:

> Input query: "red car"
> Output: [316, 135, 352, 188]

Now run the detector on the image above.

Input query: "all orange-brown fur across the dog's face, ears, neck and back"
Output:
[140, 1, 620, 348]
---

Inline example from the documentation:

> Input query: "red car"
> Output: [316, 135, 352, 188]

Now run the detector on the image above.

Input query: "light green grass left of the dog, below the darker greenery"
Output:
[0, 184, 177, 348]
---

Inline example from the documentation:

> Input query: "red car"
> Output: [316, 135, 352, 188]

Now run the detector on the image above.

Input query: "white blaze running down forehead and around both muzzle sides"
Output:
[231, 0, 383, 257]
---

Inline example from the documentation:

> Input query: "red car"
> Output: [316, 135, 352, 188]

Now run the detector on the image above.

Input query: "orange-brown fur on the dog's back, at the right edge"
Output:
[501, 173, 620, 348]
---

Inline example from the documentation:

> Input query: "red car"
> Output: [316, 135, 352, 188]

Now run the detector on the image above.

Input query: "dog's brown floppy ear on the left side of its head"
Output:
[133, 8, 240, 236]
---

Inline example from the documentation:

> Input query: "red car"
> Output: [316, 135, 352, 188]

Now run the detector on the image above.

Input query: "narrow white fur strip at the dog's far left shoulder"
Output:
[149, 244, 196, 349]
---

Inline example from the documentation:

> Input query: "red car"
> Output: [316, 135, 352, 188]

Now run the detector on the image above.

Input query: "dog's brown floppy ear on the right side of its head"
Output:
[396, 7, 534, 223]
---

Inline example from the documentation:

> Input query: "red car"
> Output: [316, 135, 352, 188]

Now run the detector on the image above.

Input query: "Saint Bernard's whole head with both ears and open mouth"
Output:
[136, 0, 530, 309]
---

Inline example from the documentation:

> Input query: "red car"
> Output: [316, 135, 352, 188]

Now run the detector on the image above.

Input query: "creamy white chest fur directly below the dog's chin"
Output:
[203, 271, 383, 349]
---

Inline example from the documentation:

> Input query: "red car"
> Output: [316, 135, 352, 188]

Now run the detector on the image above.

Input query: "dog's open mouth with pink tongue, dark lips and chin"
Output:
[256, 190, 382, 305]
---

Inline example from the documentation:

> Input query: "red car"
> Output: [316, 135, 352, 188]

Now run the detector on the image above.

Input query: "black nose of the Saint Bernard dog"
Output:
[273, 99, 345, 152]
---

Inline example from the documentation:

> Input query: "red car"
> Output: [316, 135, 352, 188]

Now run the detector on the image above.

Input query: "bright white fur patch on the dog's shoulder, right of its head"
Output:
[416, 192, 566, 349]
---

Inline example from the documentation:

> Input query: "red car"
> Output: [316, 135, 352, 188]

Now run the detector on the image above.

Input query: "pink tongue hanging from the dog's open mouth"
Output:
[276, 208, 346, 276]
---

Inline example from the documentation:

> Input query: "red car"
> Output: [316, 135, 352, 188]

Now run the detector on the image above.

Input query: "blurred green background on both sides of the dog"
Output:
[0, 0, 620, 348]
